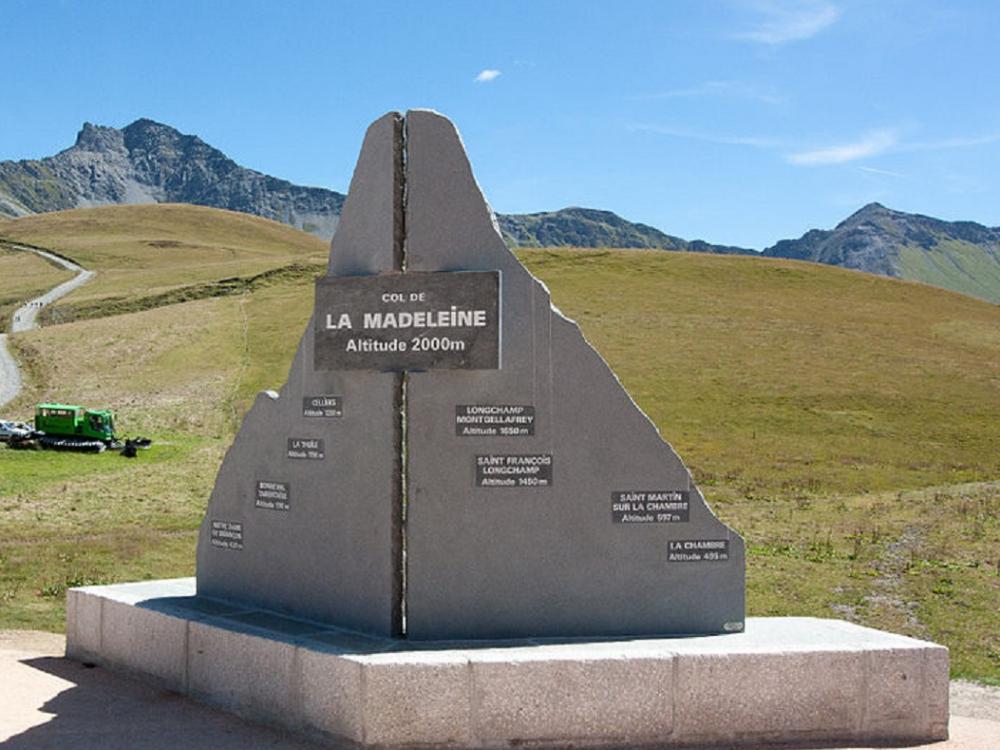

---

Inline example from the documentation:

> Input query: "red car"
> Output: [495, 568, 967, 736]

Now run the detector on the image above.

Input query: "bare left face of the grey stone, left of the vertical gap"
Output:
[197, 113, 402, 635]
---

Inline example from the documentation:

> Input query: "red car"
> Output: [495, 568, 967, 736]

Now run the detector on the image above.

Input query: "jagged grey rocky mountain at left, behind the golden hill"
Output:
[0, 120, 344, 237]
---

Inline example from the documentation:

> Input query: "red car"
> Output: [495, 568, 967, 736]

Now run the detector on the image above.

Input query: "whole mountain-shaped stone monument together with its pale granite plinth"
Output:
[66, 110, 948, 749]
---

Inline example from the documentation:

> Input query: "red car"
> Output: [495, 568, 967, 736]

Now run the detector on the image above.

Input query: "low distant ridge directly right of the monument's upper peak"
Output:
[497, 208, 756, 255]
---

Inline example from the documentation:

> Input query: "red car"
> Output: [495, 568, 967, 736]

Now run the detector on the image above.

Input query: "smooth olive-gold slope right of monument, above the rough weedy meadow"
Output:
[524, 251, 1000, 496]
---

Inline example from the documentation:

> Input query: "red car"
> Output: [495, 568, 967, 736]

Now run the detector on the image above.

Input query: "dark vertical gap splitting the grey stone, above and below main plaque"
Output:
[392, 115, 407, 638]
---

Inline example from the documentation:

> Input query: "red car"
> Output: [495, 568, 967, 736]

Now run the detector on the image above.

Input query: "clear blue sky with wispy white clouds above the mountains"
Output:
[0, 0, 1000, 249]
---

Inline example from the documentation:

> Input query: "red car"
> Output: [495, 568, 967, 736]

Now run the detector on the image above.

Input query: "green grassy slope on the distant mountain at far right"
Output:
[899, 240, 1000, 304]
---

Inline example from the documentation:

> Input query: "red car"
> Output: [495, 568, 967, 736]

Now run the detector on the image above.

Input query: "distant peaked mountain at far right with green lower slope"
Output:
[763, 203, 1000, 303]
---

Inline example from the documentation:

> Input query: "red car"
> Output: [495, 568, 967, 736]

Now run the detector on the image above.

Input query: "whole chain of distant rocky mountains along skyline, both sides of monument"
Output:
[0, 118, 1000, 303]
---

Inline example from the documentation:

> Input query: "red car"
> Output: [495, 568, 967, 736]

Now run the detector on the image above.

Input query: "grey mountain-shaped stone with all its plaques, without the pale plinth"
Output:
[198, 110, 744, 640]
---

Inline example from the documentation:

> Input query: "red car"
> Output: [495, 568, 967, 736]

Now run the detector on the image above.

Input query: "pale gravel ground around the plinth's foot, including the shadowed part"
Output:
[0, 630, 1000, 750]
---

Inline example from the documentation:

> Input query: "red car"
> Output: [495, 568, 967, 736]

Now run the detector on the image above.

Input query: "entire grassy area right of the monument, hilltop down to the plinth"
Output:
[523, 251, 1000, 681]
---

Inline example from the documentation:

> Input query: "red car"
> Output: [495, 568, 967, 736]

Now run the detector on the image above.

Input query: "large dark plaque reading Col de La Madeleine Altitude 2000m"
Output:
[315, 271, 500, 370]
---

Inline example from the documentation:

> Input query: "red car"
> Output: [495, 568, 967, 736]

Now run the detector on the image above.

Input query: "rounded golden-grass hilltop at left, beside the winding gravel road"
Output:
[0, 204, 328, 322]
